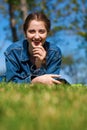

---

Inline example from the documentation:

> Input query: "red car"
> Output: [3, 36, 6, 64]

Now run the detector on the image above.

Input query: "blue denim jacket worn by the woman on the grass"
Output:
[5, 39, 62, 83]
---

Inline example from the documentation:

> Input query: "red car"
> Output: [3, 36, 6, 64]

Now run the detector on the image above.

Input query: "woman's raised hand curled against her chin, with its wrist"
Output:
[33, 46, 46, 68]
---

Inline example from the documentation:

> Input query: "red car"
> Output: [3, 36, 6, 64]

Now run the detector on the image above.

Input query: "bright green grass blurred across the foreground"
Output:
[0, 83, 87, 130]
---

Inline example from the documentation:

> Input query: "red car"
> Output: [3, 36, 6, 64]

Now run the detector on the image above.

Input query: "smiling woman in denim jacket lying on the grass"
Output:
[5, 12, 62, 85]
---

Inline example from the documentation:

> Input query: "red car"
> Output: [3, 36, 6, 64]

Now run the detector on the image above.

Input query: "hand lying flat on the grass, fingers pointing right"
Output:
[32, 74, 61, 85]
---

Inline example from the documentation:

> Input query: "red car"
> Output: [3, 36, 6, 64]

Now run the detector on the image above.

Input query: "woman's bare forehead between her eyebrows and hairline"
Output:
[28, 20, 46, 28]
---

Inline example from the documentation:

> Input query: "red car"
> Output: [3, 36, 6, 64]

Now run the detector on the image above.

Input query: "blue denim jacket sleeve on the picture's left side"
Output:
[5, 53, 31, 83]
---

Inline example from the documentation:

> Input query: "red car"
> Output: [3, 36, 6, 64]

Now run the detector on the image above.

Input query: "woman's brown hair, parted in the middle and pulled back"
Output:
[23, 12, 51, 33]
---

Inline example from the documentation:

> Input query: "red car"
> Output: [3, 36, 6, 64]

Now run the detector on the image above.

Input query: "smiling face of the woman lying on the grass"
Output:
[26, 20, 47, 50]
